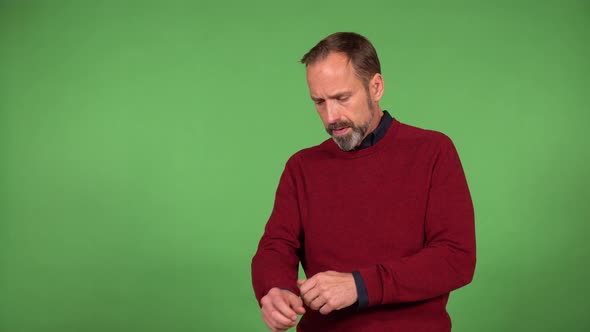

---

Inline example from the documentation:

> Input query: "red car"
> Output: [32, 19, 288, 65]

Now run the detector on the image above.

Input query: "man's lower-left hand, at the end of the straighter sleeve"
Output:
[260, 287, 305, 332]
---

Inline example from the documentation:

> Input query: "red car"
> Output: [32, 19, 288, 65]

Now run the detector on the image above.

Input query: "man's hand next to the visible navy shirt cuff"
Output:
[297, 271, 358, 315]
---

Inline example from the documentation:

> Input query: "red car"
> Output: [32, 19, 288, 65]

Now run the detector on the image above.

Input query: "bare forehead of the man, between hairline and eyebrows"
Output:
[307, 52, 362, 93]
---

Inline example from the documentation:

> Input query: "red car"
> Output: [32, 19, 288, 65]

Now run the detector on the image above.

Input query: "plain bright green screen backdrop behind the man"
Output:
[0, 0, 590, 332]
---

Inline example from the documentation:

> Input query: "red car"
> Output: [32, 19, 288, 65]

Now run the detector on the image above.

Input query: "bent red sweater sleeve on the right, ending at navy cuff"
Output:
[359, 136, 475, 306]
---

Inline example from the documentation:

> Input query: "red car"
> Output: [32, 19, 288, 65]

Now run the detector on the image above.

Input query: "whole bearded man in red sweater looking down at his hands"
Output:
[252, 33, 475, 332]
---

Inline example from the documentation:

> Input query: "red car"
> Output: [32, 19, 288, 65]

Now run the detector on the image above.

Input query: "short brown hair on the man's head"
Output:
[301, 32, 381, 87]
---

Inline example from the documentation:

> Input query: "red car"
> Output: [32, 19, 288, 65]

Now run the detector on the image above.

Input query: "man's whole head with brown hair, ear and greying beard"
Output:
[301, 32, 383, 151]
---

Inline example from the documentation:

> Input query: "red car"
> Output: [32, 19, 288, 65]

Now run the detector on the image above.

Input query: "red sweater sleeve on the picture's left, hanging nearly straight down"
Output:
[252, 157, 302, 304]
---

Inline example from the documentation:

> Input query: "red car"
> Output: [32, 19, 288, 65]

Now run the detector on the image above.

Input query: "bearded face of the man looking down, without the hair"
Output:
[307, 52, 376, 151]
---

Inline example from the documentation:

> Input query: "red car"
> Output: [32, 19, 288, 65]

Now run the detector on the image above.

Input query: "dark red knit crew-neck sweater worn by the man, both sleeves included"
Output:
[252, 120, 475, 332]
